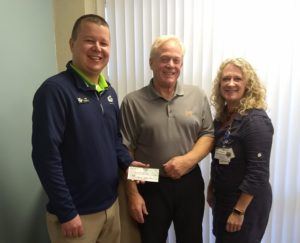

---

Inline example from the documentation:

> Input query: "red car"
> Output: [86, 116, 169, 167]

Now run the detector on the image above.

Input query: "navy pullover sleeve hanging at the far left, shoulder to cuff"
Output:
[32, 84, 77, 223]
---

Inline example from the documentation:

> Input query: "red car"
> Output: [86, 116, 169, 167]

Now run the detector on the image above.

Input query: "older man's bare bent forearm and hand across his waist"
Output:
[163, 135, 214, 179]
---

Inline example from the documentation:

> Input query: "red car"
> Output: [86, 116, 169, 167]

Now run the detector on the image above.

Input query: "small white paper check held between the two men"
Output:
[127, 166, 159, 182]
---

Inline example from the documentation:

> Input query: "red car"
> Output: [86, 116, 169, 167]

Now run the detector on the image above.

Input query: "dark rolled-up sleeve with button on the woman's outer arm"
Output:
[239, 114, 273, 196]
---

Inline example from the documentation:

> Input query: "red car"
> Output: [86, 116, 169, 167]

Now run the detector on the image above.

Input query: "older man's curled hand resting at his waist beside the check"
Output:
[163, 155, 194, 179]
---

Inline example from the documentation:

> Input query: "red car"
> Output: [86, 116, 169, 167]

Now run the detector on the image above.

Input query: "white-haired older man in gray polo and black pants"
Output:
[121, 36, 213, 243]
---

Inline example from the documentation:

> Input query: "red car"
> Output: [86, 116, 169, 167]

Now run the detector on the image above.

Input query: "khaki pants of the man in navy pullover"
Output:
[46, 200, 120, 243]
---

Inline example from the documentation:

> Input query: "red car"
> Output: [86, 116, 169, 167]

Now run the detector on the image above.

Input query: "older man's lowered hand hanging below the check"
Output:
[128, 190, 148, 224]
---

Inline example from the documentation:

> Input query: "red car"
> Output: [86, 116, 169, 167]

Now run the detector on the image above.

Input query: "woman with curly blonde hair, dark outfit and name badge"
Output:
[207, 58, 273, 243]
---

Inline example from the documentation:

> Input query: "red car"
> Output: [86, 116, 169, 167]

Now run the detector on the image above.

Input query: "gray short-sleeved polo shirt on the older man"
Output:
[121, 81, 213, 175]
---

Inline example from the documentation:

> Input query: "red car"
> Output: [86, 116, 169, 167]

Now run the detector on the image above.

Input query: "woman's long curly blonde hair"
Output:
[210, 58, 267, 121]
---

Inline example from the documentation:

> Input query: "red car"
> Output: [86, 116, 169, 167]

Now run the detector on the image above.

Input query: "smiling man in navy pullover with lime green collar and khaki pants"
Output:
[32, 14, 142, 243]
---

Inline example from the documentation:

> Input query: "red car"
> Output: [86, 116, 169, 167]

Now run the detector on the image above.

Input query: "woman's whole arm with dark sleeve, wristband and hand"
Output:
[226, 111, 273, 232]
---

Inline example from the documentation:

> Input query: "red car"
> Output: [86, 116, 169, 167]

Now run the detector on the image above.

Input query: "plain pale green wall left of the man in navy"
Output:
[0, 0, 57, 243]
